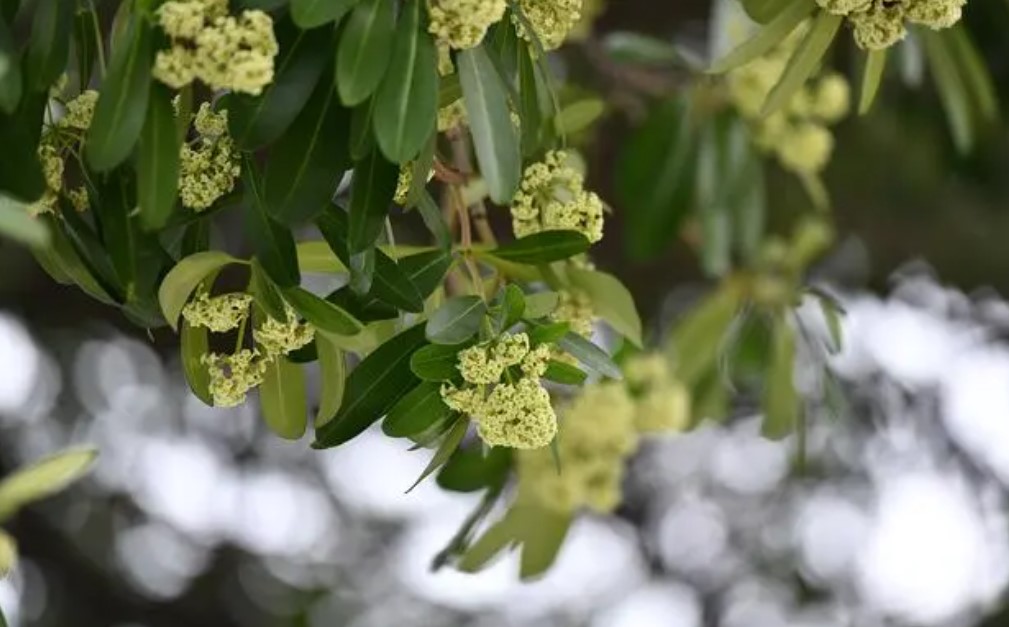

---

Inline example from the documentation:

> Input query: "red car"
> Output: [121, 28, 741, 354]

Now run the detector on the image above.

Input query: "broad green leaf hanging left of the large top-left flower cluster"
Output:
[85, 17, 153, 172]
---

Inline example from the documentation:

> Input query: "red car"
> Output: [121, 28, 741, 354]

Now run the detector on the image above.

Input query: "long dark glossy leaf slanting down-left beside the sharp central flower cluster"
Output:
[312, 324, 427, 448]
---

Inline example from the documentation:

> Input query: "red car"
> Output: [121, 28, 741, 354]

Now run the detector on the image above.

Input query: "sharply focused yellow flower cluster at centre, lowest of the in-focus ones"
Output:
[441, 333, 557, 449]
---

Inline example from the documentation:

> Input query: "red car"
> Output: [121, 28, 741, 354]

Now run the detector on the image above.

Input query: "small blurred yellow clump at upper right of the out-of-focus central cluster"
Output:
[624, 353, 690, 433]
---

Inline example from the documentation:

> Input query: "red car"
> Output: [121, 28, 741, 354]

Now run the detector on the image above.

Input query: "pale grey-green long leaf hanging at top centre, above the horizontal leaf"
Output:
[456, 45, 522, 205]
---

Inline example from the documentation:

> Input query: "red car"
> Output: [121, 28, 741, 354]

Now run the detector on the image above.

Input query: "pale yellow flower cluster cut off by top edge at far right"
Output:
[816, 0, 967, 50]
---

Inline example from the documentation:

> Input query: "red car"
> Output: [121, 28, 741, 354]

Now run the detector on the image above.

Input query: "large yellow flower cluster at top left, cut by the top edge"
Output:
[153, 0, 278, 96]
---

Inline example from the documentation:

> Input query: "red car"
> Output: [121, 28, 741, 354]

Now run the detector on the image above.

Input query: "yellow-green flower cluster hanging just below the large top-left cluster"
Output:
[179, 102, 241, 211]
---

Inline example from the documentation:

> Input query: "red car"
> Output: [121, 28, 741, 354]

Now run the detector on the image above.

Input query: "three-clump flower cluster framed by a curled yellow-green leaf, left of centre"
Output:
[183, 289, 315, 407]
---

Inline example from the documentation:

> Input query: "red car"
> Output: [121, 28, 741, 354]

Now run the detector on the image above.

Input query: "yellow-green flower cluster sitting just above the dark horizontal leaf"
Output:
[512, 150, 602, 242]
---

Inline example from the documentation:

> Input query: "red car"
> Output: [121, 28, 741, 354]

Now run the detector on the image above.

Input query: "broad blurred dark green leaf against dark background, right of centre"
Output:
[615, 95, 697, 260]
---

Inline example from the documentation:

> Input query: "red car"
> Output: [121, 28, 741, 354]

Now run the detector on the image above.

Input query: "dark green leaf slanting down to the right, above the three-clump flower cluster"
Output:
[242, 159, 302, 288]
